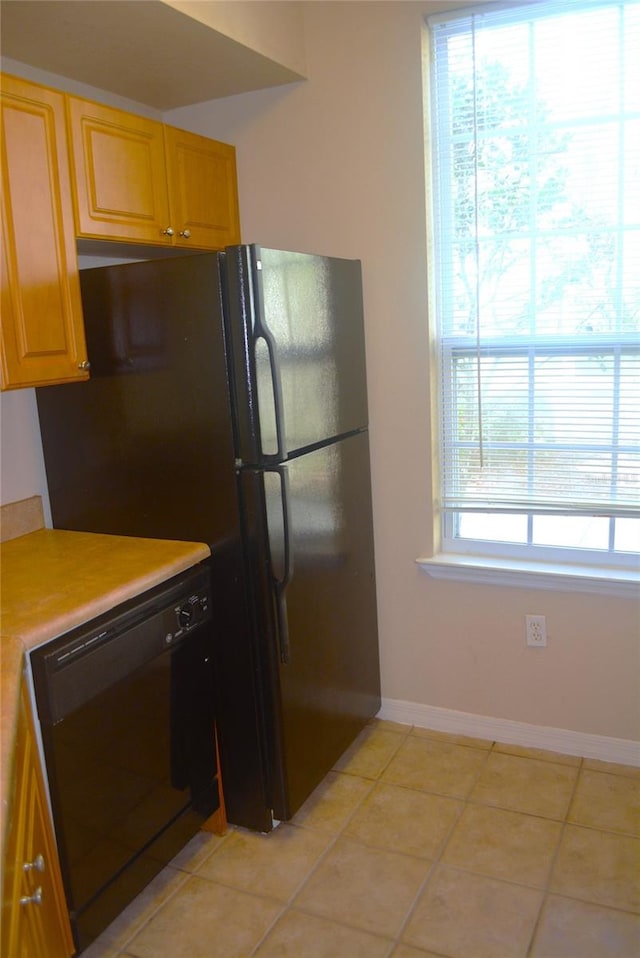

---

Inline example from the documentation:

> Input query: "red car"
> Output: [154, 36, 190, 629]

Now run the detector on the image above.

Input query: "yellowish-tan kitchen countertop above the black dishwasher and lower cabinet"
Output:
[0, 529, 211, 872]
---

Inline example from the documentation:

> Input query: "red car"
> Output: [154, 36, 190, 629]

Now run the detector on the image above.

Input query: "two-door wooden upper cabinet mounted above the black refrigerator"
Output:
[67, 96, 240, 249]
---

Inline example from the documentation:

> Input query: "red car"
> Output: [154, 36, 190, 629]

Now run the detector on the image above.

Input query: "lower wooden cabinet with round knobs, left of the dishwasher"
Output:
[2, 687, 75, 958]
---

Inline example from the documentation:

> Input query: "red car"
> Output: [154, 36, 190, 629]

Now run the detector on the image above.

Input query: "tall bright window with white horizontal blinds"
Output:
[430, 0, 640, 568]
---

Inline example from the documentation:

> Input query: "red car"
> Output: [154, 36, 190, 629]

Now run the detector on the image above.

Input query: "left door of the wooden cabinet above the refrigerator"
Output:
[66, 96, 172, 246]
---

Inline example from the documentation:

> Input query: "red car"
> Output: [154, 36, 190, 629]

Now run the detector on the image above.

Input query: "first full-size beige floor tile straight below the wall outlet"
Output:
[470, 752, 578, 820]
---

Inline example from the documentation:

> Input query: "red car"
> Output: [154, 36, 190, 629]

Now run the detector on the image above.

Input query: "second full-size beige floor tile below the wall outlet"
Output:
[442, 805, 562, 888]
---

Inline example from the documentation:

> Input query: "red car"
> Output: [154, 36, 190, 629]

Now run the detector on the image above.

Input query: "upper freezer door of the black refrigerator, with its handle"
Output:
[225, 246, 368, 465]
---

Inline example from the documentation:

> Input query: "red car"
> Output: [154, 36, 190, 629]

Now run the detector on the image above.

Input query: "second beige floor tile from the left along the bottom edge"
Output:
[127, 875, 282, 958]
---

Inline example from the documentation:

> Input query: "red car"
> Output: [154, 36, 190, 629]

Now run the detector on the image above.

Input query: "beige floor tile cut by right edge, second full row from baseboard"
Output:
[550, 825, 640, 911]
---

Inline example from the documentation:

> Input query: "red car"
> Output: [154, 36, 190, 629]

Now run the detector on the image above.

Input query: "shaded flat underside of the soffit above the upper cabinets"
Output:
[0, 0, 303, 111]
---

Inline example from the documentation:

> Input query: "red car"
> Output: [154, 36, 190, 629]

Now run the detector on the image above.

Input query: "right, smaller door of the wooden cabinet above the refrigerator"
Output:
[164, 126, 240, 249]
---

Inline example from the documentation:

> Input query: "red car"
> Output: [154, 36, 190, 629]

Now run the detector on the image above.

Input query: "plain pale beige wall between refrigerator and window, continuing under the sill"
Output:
[165, 2, 640, 739]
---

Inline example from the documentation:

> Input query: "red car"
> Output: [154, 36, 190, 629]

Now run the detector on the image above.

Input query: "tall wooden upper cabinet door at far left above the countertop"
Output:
[0, 75, 88, 389]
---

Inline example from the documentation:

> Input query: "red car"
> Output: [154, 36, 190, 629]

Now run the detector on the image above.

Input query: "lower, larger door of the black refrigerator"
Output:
[242, 431, 380, 819]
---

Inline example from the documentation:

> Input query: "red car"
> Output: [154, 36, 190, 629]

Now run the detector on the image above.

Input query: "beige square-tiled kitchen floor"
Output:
[84, 721, 640, 958]
